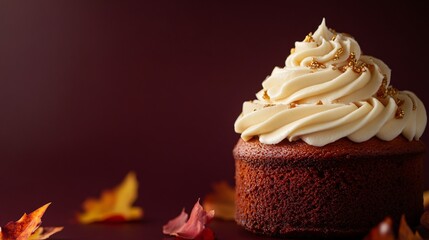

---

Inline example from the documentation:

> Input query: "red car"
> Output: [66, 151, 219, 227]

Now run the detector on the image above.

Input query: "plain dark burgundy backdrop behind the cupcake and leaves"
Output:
[0, 1, 429, 239]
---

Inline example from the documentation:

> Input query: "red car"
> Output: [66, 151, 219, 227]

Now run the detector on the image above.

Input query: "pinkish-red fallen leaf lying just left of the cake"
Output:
[162, 199, 215, 240]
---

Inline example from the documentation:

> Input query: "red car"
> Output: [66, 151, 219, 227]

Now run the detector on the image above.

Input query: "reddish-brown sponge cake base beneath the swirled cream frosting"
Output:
[233, 137, 425, 237]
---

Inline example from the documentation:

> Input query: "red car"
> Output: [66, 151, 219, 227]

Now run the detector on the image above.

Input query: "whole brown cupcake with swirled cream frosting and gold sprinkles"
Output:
[233, 20, 427, 237]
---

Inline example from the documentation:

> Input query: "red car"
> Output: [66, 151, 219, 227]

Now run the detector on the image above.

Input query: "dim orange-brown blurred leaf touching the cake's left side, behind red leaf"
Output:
[203, 181, 235, 220]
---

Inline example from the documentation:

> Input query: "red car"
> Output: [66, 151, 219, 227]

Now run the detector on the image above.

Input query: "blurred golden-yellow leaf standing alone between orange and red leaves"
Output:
[77, 172, 143, 224]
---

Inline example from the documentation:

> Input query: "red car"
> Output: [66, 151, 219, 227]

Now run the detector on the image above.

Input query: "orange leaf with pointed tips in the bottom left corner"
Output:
[0, 203, 63, 240]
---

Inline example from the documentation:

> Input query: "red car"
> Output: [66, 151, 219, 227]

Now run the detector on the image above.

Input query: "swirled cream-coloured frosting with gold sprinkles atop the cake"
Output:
[234, 19, 427, 146]
